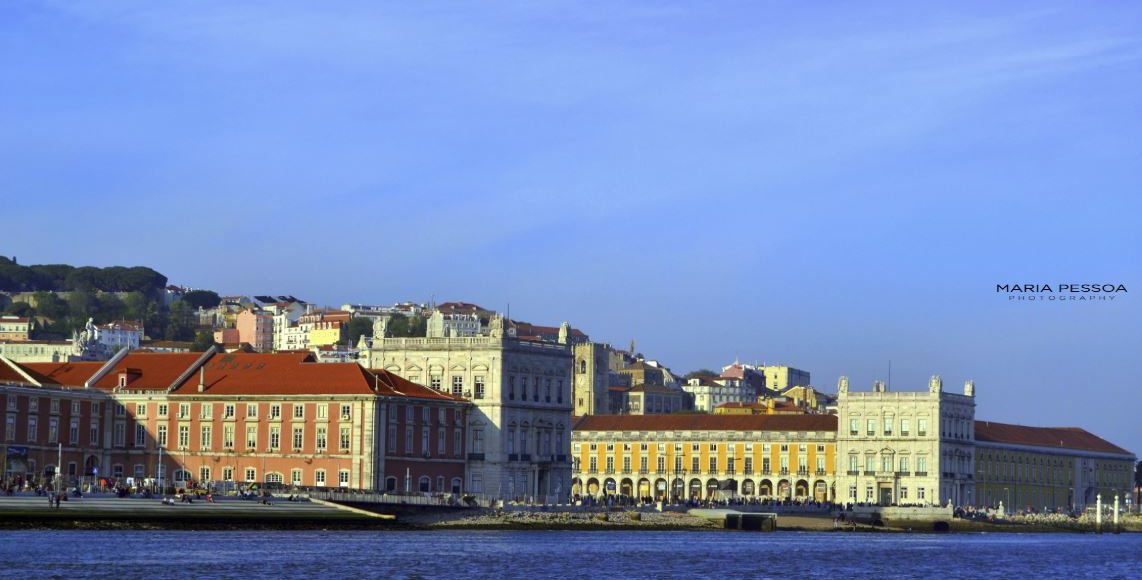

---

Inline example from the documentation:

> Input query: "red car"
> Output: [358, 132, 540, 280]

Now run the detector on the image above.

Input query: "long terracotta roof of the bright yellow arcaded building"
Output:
[573, 414, 837, 432]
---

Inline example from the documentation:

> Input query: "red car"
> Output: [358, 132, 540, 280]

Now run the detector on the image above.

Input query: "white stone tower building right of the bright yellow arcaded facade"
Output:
[837, 376, 975, 506]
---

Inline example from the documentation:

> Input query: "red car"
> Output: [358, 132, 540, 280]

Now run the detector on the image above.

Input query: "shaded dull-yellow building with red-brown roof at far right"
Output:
[975, 421, 1136, 511]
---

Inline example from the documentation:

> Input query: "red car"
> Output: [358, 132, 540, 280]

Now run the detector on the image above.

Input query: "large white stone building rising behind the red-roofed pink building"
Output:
[359, 316, 573, 499]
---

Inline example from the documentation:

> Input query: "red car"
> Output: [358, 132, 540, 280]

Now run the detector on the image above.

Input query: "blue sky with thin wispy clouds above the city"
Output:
[0, 0, 1142, 452]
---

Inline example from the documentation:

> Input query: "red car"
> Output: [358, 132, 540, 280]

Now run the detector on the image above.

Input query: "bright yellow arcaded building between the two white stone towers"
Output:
[571, 414, 837, 501]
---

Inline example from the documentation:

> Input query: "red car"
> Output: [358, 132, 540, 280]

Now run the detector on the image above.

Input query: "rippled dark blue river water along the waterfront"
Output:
[0, 531, 1142, 580]
